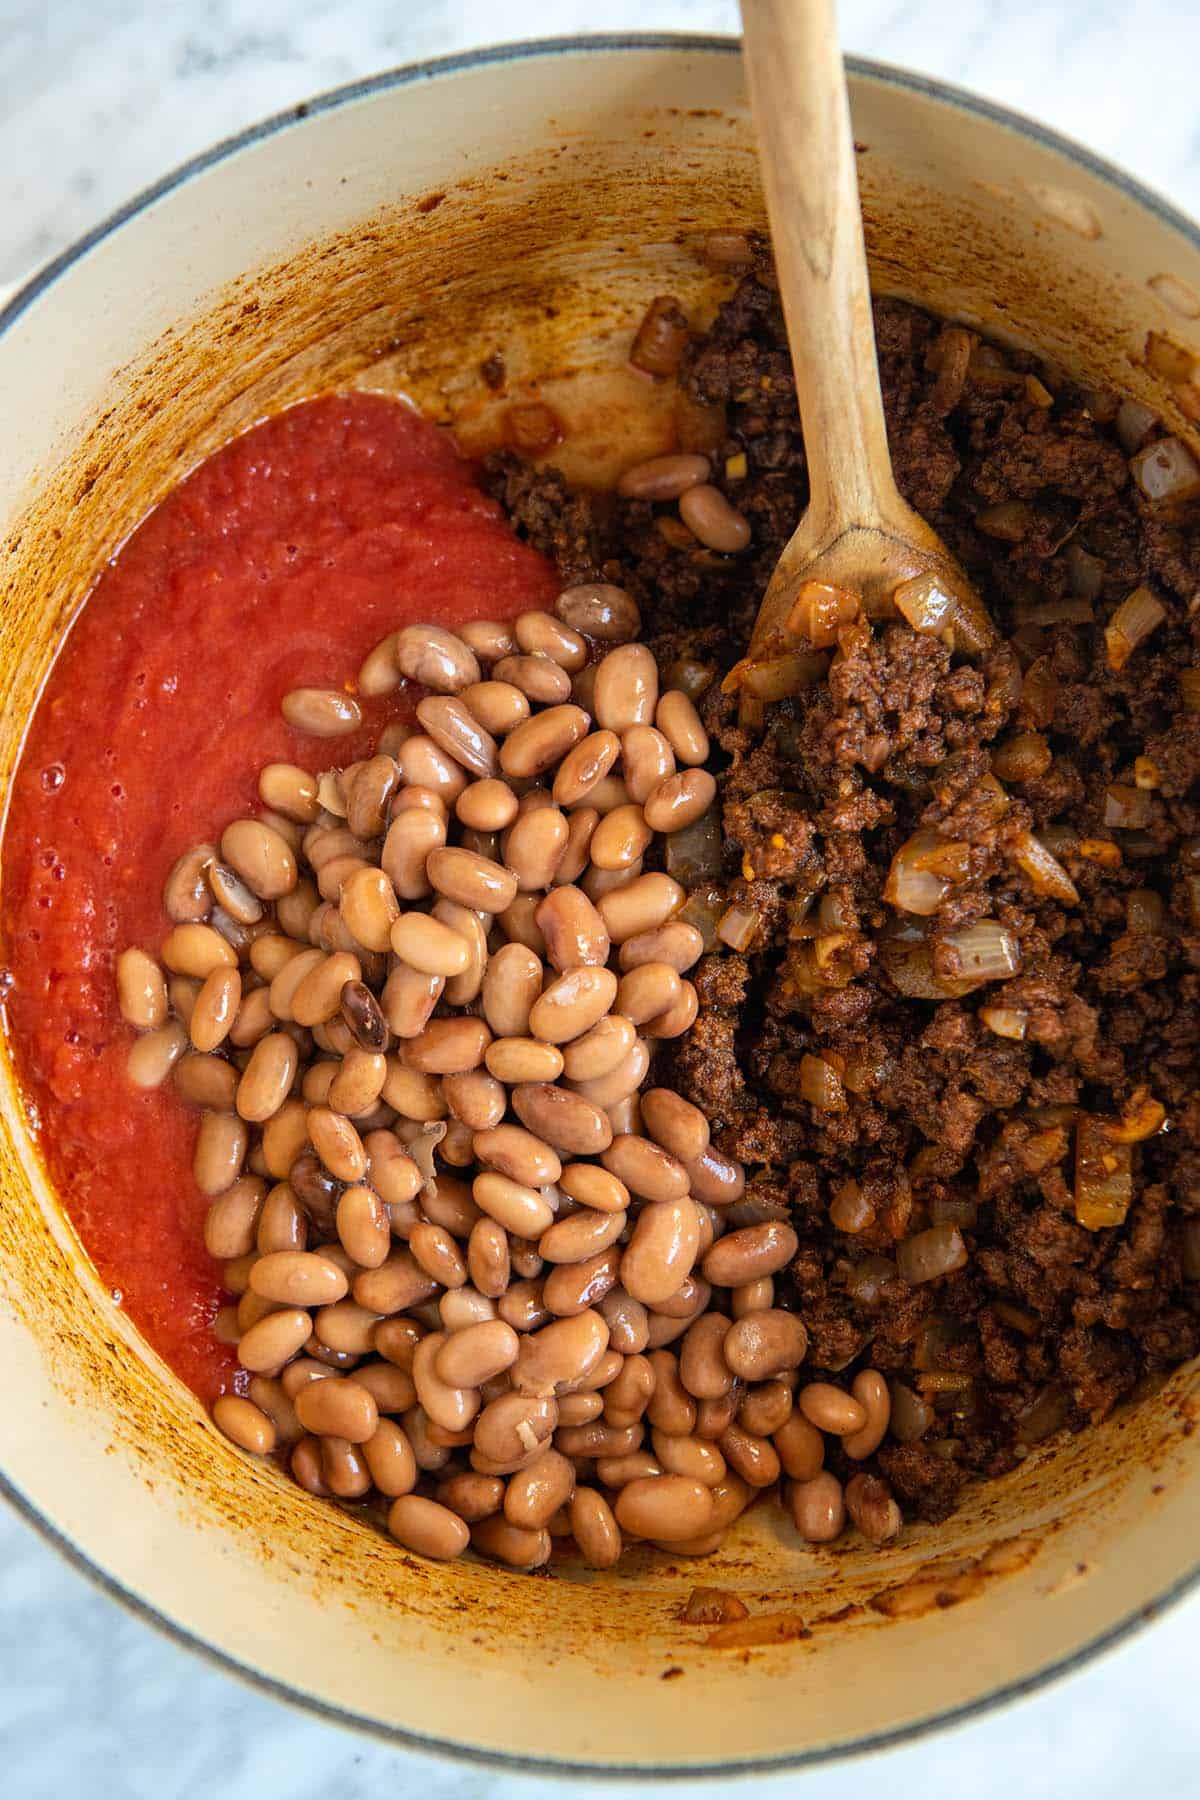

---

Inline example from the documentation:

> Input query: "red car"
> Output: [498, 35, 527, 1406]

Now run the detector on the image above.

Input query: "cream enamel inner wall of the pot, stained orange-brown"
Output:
[0, 40, 1200, 1771]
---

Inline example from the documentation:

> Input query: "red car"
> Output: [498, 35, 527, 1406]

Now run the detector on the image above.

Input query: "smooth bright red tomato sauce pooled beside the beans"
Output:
[0, 394, 556, 1400]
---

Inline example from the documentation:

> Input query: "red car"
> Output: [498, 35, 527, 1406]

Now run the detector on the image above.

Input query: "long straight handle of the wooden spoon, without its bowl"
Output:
[741, 0, 896, 527]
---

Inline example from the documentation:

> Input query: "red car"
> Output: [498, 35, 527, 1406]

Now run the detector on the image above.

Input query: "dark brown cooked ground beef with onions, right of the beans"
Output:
[489, 261, 1200, 1519]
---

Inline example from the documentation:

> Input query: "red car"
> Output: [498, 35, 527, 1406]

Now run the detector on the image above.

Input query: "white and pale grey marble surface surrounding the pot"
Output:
[0, 0, 1200, 1800]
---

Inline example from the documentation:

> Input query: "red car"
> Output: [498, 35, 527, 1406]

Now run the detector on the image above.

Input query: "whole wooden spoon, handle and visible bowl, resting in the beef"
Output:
[730, 0, 997, 686]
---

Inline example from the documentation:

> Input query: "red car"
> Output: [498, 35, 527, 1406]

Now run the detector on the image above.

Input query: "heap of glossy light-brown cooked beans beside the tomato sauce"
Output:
[117, 585, 900, 1570]
